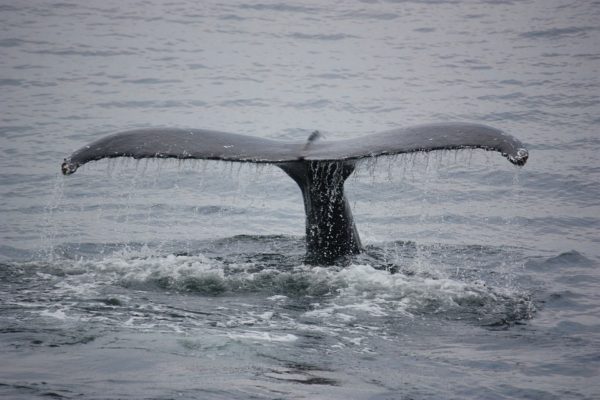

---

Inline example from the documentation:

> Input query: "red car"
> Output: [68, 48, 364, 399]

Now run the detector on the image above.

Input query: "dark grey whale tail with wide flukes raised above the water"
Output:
[61, 123, 529, 265]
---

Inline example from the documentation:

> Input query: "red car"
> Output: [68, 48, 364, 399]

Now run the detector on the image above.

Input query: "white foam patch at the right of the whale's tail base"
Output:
[292, 265, 516, 327]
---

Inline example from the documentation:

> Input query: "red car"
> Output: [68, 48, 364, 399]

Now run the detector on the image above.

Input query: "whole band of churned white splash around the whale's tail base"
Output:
[17, 247, 535, 327]
